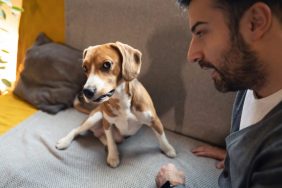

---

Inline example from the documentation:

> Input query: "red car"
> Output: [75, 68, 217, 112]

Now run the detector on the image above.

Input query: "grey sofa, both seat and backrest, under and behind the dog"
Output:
[0, 0, 234, 188]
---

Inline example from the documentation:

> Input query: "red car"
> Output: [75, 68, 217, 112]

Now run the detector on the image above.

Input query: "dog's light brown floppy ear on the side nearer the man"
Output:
[114, 41, 142, 81]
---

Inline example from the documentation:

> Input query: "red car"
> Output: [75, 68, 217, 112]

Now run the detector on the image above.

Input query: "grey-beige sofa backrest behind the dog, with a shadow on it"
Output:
[65, 0, 234, 145]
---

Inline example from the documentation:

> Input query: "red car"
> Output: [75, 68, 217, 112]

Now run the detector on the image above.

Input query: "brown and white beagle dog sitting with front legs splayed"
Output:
[56, 42, 176, 168]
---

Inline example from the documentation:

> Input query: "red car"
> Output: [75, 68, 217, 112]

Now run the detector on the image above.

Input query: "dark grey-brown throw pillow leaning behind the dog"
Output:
[14, 33, 86, 114]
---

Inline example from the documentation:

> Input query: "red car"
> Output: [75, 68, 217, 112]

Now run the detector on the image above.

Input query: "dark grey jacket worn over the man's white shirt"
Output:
[219, 91, 282, 188]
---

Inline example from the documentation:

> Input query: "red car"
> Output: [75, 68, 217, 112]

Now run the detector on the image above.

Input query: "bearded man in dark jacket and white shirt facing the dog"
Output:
[156, 0, 282, 188]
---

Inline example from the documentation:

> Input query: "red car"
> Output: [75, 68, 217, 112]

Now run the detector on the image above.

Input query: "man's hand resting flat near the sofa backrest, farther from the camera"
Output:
[192, 145, 226, 169]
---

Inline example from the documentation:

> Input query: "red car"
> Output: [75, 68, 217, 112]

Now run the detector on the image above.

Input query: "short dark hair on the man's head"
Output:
[177, 0, 282, 38]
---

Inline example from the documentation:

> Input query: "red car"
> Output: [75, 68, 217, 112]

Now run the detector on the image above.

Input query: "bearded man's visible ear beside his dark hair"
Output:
[243, 2, 272, 41]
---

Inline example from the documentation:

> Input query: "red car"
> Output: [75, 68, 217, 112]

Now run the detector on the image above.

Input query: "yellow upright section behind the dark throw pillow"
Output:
[17, 0, 65, 78]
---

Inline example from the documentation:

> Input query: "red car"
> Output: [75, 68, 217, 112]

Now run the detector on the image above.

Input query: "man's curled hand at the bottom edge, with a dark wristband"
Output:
[156, 163, 185, 188]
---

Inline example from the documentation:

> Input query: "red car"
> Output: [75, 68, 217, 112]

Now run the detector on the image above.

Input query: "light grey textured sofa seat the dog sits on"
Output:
[0, 109, 221, 188]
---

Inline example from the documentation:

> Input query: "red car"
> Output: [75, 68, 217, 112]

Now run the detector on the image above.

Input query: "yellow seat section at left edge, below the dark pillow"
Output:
[0, 93, 37, 135]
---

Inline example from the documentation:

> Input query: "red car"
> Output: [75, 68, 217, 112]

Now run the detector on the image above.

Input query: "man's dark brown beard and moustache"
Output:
[199, 34, 266, 92]
